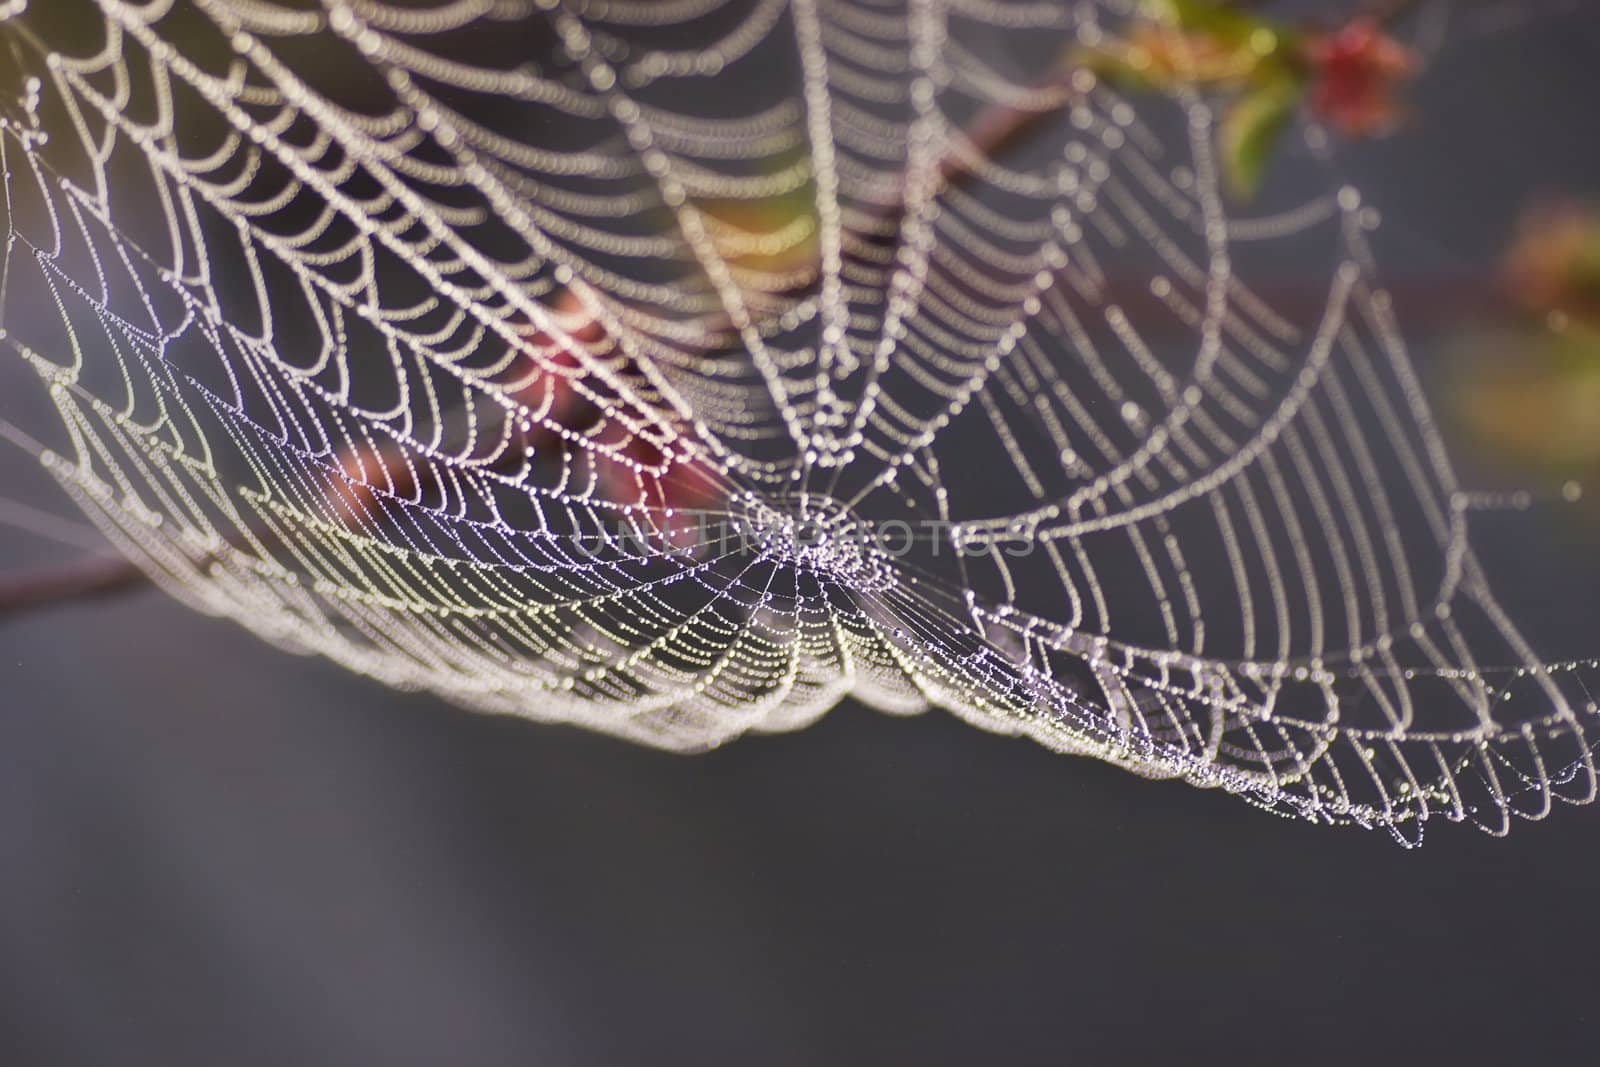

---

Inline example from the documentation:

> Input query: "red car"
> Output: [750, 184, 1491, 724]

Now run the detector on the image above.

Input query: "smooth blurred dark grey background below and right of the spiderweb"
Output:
[9, 5, 1600, 1067]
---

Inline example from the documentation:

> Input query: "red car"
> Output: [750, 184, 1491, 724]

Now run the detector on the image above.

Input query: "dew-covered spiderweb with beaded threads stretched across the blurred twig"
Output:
[0, 0, 1595, 840]
